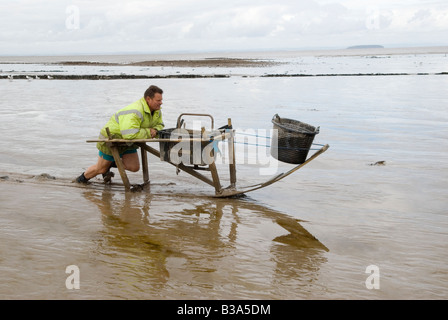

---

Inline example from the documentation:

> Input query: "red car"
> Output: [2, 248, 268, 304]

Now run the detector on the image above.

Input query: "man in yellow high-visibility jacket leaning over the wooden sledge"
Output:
[76, 86, 164, 183]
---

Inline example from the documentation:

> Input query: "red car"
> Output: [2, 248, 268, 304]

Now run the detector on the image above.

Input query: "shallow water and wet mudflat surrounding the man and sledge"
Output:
[0, 47, 448, 300]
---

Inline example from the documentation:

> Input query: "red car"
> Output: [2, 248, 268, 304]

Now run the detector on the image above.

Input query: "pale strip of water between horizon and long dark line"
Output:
[0, 47, 448, 79]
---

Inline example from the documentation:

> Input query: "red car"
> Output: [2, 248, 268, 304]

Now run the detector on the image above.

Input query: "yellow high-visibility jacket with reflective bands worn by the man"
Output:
[97, 98, 165, 155]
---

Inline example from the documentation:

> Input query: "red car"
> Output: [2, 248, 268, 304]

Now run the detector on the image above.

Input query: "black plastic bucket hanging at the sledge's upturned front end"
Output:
[271, 114, 319, 164]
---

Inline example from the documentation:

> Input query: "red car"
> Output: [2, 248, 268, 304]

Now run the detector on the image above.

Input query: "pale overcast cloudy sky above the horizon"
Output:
[0, 0, 448, 55]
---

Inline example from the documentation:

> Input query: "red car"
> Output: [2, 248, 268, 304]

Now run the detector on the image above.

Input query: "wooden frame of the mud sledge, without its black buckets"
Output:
[87, 113, 329, 198]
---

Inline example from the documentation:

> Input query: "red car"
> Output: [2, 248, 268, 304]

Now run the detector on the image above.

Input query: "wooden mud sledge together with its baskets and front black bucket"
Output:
[87, 113, 329, 198]
